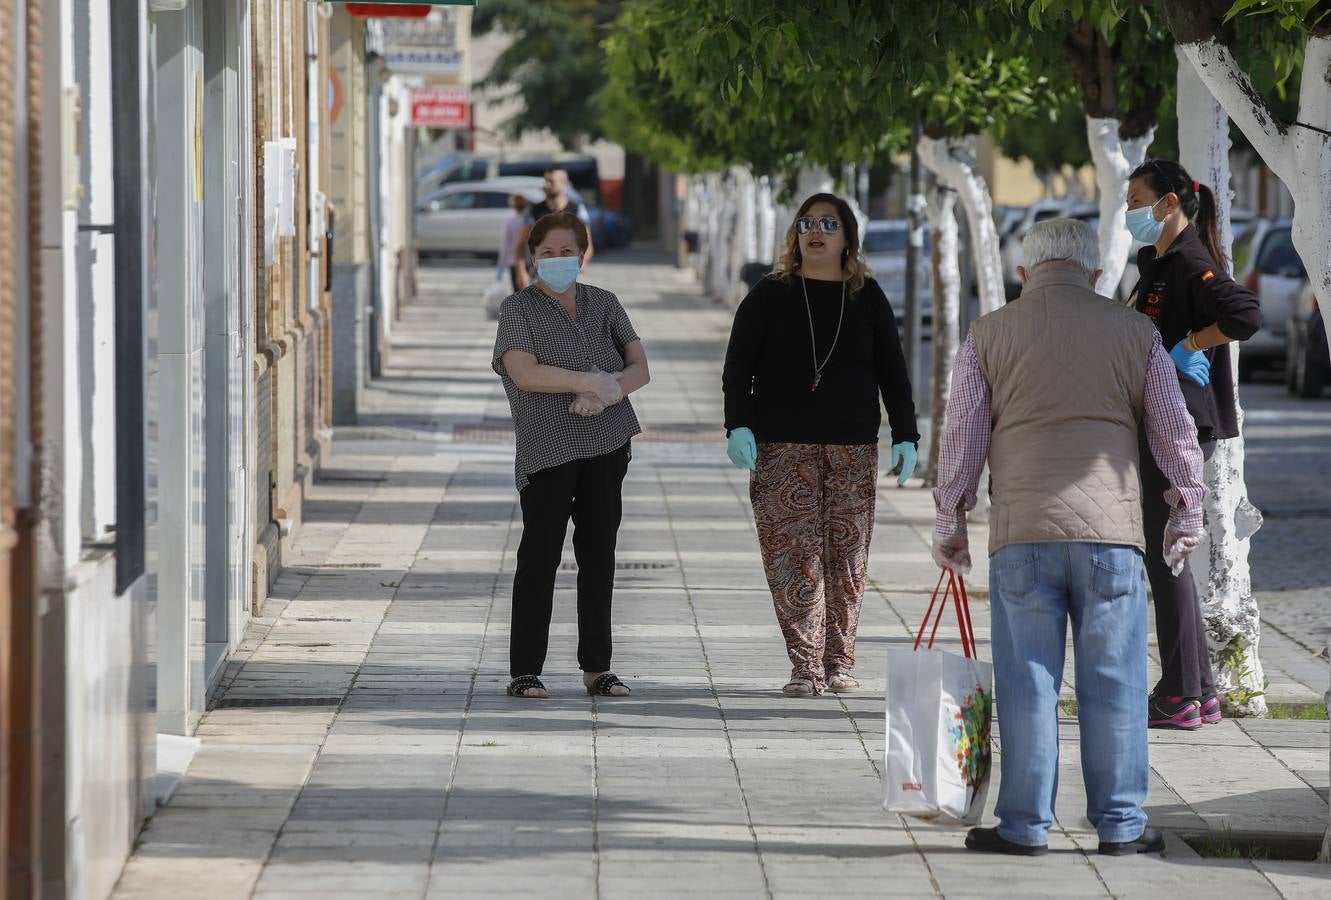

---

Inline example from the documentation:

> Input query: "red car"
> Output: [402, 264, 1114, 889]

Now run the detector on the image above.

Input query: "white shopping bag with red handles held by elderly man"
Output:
[882, 578, 993, 825]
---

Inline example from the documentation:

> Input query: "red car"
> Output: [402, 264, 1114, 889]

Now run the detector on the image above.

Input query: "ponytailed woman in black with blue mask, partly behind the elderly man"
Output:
[1126, 160, 1262, 731]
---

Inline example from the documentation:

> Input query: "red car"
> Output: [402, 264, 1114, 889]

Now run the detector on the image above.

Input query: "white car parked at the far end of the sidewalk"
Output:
[415, 176, 582, 257]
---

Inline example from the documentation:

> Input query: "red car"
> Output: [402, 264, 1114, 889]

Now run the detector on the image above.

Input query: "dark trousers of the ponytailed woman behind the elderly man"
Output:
[1141, 441, 1215, 698]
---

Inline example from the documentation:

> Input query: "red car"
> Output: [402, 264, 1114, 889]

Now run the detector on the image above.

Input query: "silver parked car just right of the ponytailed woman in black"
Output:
[1234, 218, 1307, 381]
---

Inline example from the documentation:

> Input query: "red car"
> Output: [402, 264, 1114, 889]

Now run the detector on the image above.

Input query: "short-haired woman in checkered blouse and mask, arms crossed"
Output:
[492, 212, 650, 699]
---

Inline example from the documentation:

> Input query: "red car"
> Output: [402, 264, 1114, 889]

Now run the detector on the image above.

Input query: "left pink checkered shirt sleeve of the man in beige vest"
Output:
[933, 336, 993, 538]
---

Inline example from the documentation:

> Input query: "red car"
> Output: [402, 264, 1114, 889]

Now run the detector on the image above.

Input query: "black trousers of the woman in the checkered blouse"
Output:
[508, 445, 628, 678]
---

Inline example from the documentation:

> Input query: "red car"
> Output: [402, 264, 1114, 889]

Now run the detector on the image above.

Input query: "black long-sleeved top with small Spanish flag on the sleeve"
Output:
[1133, 225, 1262, 443]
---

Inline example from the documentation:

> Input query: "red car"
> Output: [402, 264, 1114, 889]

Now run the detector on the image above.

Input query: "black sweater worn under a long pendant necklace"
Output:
[721, 276, 920, 443]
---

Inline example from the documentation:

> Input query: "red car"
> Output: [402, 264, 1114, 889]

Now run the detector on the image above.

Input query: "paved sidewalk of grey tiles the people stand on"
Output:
[116, 253, 1331, 900]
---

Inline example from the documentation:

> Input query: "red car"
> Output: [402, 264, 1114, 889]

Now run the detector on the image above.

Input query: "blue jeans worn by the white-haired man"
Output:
[989, 543, 1150, 845]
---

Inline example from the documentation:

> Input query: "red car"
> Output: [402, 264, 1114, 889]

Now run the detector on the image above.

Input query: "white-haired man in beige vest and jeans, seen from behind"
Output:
[933, 218, 1206, 856]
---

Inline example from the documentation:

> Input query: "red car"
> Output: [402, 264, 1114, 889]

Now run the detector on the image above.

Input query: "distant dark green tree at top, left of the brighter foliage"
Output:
[471, 0, 624, 148]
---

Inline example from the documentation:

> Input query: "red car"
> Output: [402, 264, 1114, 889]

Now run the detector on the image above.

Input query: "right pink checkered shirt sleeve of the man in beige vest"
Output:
[1142, 332, 1206, 531]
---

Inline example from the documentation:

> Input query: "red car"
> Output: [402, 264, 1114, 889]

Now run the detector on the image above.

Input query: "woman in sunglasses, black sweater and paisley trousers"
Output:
[721, 193, 920, 696]
